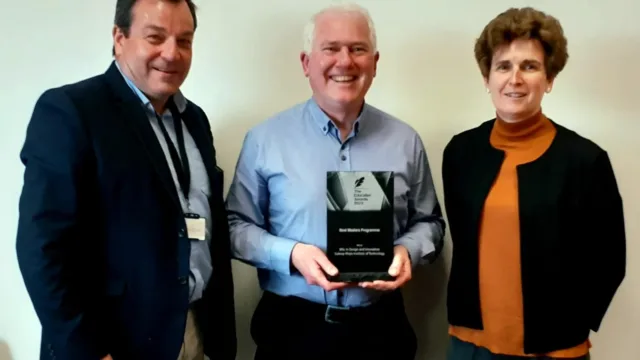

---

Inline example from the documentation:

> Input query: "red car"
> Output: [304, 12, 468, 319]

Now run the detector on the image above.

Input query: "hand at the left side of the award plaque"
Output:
[291, 243, 350, 291]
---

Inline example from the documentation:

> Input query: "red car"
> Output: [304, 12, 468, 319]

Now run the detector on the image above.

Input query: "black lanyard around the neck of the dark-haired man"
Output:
[156, 98, 191, 204]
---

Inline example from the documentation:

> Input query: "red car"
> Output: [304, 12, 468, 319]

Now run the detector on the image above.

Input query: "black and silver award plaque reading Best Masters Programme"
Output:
[327, 171, 394, 282]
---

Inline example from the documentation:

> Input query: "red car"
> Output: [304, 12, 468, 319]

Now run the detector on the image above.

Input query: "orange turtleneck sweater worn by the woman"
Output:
[449, 112, 591, 358]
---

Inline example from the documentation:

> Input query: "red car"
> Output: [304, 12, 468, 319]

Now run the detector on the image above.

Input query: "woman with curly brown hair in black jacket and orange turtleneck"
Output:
[442, 8, 626, 360]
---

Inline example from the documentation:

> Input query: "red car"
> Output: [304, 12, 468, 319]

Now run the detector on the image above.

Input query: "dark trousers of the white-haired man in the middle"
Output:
[251, 291, 417, 360]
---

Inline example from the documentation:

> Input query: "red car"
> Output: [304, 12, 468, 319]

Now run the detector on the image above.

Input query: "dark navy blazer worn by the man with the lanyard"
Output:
[16, 63, 236, 360]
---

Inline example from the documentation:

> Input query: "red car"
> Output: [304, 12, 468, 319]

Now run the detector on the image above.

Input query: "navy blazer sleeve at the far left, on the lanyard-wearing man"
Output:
[16, 89, 106, 360]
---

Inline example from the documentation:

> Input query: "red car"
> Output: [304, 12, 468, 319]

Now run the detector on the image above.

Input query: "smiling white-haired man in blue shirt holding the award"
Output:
[227, 2, 445, 360]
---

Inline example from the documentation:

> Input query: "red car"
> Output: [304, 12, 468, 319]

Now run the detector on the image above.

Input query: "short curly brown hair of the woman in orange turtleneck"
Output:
[474, 7, 569, 80]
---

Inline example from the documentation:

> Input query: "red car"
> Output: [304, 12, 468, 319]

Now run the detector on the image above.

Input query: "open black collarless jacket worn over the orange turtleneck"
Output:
[442, 119, 626, 353]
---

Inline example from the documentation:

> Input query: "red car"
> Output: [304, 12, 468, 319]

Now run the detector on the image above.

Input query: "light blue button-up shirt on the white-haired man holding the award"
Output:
[227, 99, 445, 307]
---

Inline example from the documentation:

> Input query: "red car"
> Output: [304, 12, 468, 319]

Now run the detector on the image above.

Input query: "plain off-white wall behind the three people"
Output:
[0, 0, 640, 360]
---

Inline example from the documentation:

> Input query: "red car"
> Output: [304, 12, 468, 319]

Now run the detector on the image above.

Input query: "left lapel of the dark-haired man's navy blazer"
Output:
[105, 63, 182, 211]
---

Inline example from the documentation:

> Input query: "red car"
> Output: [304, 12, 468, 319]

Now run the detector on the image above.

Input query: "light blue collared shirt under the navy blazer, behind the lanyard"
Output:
[116, 61, 213, 302]
